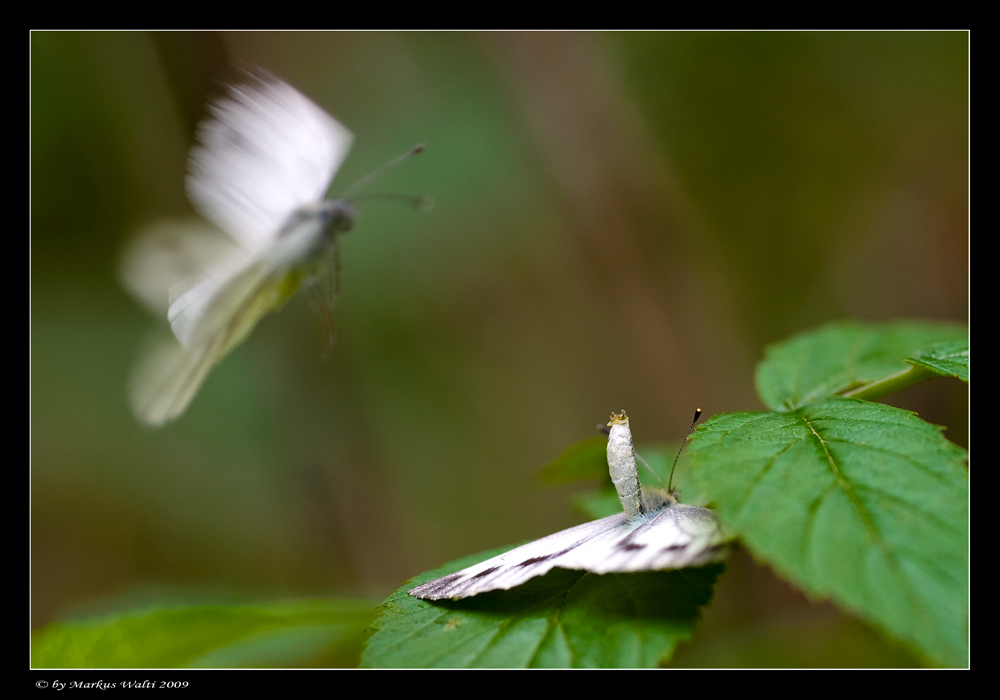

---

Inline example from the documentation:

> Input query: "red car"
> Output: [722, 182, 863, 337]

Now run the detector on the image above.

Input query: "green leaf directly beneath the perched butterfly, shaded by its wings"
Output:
[362, 547, 722, 668]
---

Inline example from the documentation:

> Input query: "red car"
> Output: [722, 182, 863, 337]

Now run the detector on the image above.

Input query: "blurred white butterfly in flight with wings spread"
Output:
[122, 75, 353, 425]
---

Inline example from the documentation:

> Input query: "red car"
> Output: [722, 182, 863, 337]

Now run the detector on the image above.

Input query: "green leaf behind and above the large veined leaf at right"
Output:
[756, 321, 968, 411]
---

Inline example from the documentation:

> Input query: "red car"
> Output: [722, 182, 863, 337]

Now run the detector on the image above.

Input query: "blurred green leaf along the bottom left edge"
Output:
[31, 600, 375, 668]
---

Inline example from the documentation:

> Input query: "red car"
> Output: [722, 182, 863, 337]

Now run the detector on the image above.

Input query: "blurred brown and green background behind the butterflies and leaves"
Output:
[31, 32, 969, 665]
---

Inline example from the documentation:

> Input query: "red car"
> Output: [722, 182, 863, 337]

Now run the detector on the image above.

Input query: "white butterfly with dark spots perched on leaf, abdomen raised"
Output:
[409, 411, 728, 600]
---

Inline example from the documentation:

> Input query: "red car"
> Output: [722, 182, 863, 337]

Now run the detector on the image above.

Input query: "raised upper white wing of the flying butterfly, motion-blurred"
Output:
[187, 75, 353, 251]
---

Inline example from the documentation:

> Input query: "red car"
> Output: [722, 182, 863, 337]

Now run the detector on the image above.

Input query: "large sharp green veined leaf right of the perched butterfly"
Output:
[689, 398, 969, 666]
